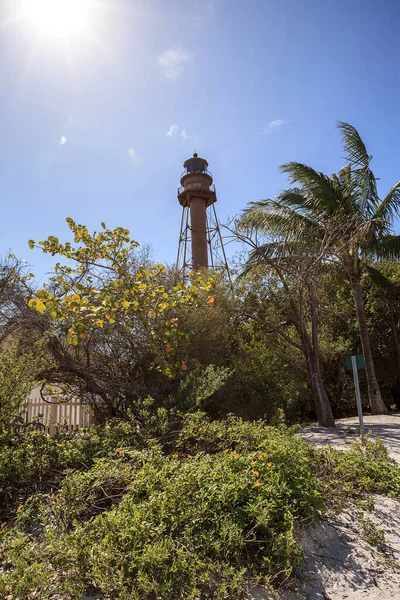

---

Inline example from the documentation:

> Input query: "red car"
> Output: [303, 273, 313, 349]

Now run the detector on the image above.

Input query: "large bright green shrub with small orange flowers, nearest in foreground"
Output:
[0, 432, 321, 600]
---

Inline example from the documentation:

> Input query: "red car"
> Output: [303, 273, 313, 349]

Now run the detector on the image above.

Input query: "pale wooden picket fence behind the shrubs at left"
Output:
[24, 389, 92, 435]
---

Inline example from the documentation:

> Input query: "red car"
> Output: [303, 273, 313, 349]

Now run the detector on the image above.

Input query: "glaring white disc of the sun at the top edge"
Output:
[24, 0, 91, 37]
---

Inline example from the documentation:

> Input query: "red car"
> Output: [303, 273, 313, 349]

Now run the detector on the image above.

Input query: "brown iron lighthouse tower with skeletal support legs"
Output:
[177, 153, 229, 277]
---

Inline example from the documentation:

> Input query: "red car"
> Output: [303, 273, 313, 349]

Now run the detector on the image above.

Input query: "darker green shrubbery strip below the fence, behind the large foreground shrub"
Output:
[0, 399, 182, 520]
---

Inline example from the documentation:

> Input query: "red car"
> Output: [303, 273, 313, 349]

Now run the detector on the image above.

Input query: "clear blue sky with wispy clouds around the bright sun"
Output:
[0, 0, 400, 276]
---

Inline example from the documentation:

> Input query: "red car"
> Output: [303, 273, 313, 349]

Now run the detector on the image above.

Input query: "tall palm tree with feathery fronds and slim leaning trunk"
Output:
[247, 122, 400, 414]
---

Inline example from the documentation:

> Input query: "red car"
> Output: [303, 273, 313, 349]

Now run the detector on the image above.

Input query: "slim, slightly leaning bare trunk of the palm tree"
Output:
[350, 274, 387, 415]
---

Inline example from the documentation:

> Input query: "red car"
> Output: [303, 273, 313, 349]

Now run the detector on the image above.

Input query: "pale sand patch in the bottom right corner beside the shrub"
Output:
[252, 496, 400, 600]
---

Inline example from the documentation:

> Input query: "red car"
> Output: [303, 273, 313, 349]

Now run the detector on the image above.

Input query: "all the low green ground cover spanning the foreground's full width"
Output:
[0, 407, 400, 600]
